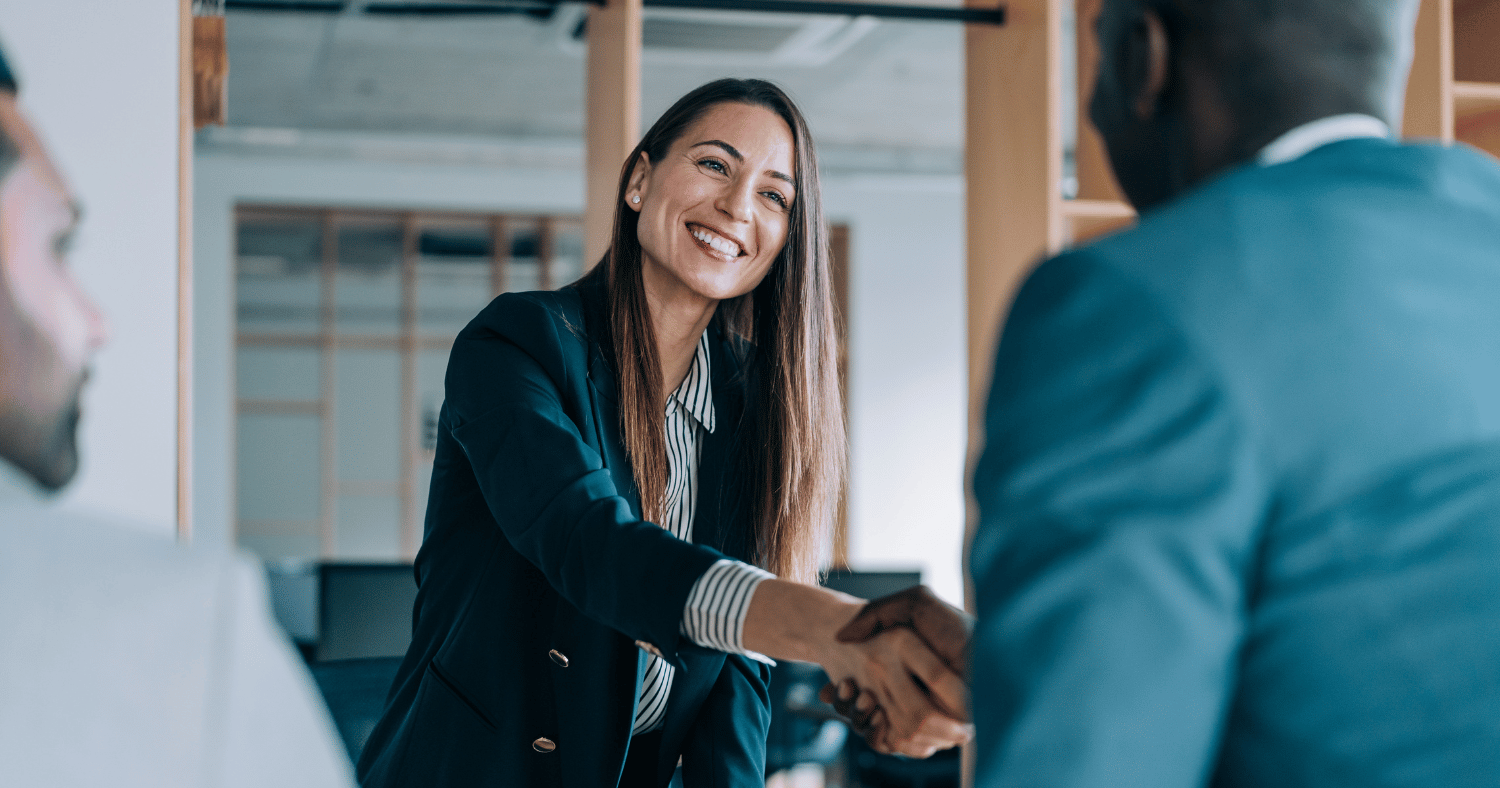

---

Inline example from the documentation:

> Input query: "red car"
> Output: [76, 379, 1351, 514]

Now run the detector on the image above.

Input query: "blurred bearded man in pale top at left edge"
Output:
[0, 44, 351, 786]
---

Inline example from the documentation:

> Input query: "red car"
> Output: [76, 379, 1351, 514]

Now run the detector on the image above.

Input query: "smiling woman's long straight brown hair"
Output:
[590, 80, 848, 582]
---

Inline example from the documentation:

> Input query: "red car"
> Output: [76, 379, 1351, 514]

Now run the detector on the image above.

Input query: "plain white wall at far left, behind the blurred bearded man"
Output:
[0, 0, 177, 533]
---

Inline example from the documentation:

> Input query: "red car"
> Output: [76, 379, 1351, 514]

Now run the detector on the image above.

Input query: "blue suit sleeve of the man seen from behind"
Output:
[969, 251, 1266, 788]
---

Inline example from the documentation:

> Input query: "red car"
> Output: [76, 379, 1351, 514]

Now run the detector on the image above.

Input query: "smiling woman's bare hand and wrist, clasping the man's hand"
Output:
[743, 579, 972, 758]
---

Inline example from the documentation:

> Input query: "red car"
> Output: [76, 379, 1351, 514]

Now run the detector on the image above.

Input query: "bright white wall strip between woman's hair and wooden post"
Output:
[824, 176, 968, 606]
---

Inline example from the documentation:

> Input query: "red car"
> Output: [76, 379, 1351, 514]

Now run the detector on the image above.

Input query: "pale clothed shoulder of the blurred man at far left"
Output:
[0, 507, 350, 785]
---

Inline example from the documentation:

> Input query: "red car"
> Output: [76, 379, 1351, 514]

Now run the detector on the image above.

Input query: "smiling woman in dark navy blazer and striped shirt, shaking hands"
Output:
[359, 80, 966, 788]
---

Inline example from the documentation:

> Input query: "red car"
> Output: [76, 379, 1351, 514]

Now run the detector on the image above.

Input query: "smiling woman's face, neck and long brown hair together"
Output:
[594, 80, 845, 581]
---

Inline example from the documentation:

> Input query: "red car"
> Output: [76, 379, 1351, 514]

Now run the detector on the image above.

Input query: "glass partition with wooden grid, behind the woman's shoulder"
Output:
[236, 207, 584, 561]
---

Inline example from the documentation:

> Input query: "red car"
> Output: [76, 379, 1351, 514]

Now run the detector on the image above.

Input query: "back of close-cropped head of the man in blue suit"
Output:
[1091, 0, 1418, 209]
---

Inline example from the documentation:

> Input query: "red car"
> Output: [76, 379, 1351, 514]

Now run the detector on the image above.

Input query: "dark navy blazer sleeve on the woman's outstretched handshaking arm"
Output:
[444, 291, 725, 666]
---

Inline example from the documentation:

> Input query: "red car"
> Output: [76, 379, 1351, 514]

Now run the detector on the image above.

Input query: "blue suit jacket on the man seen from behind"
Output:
[971, 140, 1500, 788]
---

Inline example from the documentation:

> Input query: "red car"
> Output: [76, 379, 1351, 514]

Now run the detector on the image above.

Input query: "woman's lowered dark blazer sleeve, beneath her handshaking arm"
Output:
[683, 654, 771, 788]
